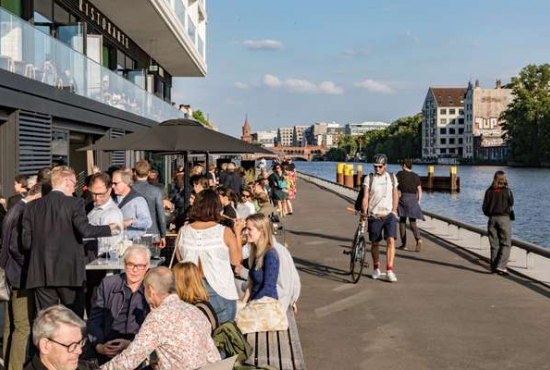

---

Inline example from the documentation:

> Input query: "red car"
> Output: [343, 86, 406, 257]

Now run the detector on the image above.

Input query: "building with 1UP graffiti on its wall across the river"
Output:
[464, 80, 513, 161]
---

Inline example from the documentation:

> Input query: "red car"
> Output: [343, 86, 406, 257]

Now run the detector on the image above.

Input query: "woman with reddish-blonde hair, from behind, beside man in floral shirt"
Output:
[176, 262, 219, 331]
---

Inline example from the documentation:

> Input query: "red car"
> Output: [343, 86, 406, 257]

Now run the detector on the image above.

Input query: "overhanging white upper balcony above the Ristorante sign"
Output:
[90, 0, 207, 77]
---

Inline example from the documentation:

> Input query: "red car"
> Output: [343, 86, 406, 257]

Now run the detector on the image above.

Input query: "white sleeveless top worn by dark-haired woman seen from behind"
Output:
[177, 224, 239, 300]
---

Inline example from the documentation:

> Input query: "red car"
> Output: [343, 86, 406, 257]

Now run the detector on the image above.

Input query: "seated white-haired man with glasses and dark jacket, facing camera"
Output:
[87, 245, 151, 363]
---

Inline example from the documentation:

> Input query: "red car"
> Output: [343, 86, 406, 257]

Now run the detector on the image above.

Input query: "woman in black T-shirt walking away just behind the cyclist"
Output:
[396, 159, 424, 252]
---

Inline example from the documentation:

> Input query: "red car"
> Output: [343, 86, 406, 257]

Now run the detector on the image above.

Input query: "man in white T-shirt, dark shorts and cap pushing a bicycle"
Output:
[361, 154, 399, 283]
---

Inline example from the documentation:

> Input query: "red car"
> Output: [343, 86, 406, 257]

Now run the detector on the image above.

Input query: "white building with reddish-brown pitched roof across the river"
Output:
[422, 87, 466, 160]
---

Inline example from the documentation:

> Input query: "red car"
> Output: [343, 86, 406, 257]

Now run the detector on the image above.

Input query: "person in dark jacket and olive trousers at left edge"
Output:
[0, 185, 42, 369]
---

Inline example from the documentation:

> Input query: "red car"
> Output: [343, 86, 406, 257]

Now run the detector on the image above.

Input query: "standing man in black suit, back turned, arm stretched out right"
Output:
[22, 166, 120, 317]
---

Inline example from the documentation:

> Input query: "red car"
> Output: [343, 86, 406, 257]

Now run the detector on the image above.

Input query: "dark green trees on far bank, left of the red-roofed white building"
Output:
[361, 113, 422, 163]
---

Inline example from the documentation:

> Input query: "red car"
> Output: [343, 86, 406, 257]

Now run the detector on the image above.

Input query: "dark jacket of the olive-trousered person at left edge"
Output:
[0, 200, 29, 289]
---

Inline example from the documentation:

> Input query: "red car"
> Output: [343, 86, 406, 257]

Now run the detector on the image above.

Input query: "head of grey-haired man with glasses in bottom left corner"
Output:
[25, 305, 86, 370]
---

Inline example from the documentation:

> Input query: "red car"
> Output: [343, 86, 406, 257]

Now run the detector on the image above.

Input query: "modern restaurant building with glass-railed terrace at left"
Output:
[0, 0, 207, 195]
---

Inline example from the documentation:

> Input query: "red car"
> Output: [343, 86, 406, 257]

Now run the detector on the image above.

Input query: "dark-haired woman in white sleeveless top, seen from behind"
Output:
[176, 189, 244, 324]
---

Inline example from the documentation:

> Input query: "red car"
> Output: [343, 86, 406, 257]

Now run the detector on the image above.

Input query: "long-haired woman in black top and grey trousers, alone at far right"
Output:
[483, 171, 514, 275]
